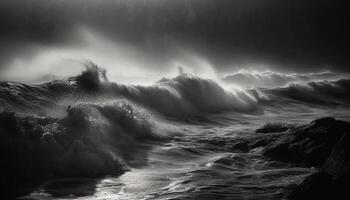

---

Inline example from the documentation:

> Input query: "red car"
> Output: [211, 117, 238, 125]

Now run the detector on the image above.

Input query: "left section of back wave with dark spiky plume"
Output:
[0, 63, 107, 113]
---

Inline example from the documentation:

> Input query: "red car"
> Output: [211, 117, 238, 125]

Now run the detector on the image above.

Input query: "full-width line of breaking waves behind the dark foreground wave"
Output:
[0, 63, 350, 119]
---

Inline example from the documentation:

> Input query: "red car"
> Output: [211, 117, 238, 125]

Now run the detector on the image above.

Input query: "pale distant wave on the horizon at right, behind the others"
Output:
[222, 71, 350, 87]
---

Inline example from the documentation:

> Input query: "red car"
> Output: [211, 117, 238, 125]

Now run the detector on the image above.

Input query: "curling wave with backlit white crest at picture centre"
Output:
[108, 74, 258, 117]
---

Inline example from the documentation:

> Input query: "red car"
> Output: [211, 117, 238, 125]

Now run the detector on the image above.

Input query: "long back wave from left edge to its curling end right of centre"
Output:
[0, 64, 258, 117]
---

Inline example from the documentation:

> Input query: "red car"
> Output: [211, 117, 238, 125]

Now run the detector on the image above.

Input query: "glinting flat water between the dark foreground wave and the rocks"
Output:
[26, 110, 347, 200]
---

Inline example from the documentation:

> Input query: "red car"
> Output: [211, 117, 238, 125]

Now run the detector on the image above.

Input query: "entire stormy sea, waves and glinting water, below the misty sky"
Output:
[0, 67, 350, 200]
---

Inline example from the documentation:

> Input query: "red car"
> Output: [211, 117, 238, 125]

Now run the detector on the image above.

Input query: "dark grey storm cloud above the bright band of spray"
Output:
[0, 0, 350, 71]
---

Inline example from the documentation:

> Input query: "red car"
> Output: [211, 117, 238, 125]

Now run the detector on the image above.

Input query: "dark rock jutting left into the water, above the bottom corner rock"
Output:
[263, 118, 350, 167]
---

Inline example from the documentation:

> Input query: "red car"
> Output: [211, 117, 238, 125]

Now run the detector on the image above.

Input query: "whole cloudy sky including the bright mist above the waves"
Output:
[0, 0, 350, 82]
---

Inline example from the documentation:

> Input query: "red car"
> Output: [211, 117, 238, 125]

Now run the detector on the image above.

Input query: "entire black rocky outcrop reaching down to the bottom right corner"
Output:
[263, 117, 350, 199]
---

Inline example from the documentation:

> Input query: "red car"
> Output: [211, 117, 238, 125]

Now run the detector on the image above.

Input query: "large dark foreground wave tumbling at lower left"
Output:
[0, 102, 166, 194]
